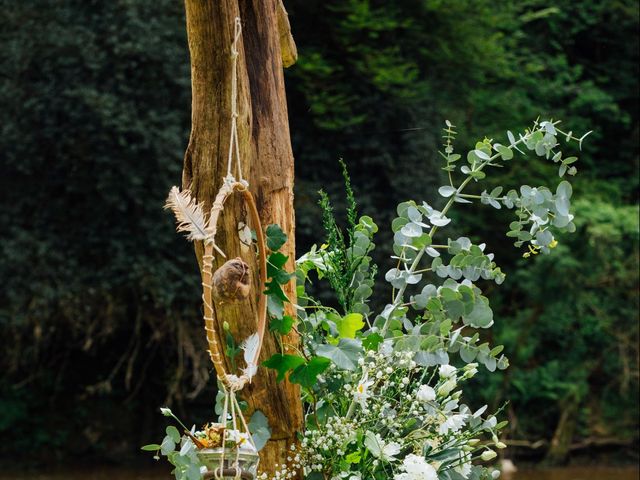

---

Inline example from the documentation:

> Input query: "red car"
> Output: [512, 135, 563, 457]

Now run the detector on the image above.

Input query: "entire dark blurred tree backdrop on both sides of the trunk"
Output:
[0, 0, 639, 460]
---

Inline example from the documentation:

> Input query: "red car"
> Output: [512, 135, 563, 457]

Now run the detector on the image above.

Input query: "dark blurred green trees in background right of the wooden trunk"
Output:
[287, 0, 640, 462]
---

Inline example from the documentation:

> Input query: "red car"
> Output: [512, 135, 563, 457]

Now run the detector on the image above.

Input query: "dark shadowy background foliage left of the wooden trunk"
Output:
[0, 0, 199, 458]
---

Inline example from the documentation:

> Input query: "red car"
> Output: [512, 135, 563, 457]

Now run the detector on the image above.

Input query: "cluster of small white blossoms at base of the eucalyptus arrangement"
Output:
[260, 348, 502, 480]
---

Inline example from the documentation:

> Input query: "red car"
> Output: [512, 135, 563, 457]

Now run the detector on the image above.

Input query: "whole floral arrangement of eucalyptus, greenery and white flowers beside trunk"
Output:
[143, 120, 588, 480]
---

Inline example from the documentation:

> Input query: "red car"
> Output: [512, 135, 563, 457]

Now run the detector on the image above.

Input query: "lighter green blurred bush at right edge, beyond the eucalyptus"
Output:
[472, 199, 639, 438]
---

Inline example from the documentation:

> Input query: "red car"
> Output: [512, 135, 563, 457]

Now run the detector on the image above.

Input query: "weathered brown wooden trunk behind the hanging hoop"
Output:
[182, 0, 303, 472]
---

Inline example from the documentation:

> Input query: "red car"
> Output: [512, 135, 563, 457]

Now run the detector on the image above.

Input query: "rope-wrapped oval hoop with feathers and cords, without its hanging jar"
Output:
[166, 18, 267, 479]
